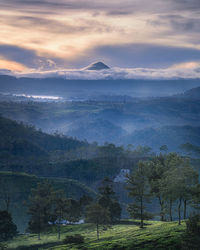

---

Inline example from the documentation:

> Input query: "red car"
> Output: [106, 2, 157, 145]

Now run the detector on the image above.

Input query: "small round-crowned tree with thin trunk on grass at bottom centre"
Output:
[86, 203, 110, 240]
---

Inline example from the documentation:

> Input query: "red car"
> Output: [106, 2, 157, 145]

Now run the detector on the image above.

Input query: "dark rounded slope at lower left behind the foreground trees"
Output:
[0, 172, 96, 232]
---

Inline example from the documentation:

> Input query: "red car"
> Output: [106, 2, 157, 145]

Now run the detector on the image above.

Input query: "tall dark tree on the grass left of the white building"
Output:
[28, 182, 55, 240]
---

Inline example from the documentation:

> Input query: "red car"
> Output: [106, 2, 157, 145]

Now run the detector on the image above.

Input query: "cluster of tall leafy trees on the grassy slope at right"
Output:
[127, 153, 199, 227]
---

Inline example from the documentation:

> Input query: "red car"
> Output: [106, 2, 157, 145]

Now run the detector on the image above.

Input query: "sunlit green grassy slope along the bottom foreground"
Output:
[5, 221, 185, 250]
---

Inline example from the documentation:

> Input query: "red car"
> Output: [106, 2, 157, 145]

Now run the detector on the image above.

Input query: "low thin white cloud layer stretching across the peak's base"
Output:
[3, 62, 200, 80]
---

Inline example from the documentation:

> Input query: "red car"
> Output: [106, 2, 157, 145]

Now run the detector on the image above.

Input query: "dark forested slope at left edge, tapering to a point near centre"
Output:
[0, 116, 88, 169]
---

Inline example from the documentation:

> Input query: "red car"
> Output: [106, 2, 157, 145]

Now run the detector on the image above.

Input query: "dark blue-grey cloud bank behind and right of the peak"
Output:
[88, 43, 200, 68]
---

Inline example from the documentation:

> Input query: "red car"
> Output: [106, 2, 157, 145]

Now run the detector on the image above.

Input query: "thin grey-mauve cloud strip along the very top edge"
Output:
[1, 0, 200, 15]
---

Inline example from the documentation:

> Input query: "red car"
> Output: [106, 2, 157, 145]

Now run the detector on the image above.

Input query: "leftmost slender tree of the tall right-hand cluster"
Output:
[126, 161, 152, 228]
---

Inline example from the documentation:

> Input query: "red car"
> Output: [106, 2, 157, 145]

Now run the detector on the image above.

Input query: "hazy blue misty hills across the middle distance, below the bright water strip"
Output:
[0, 96, 200, 151]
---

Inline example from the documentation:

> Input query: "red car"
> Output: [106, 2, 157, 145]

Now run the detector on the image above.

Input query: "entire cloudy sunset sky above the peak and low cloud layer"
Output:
[0, 0, 200, 73]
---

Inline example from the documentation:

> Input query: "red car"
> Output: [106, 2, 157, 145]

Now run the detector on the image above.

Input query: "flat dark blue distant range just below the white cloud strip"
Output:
[0, 74, 200, 99]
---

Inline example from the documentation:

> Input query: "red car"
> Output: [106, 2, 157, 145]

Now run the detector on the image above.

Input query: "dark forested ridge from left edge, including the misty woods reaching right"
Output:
[0, 117, 151, 186]
